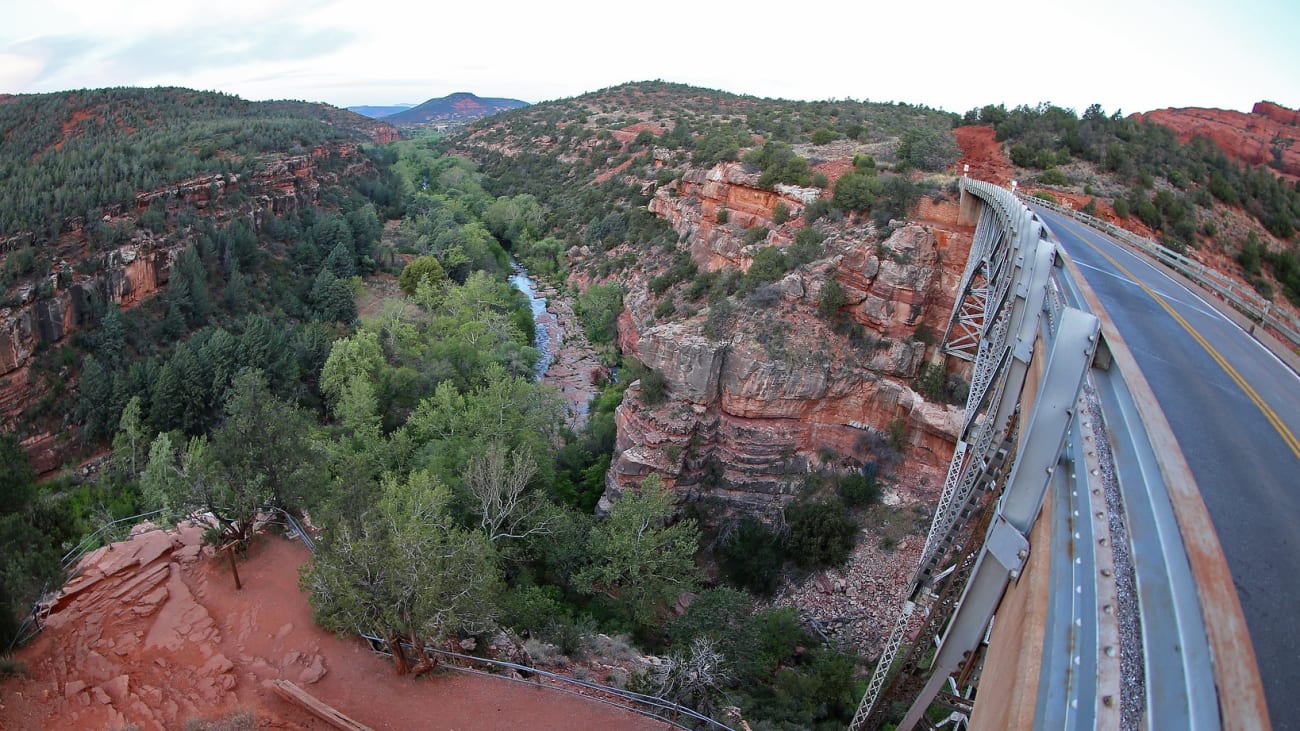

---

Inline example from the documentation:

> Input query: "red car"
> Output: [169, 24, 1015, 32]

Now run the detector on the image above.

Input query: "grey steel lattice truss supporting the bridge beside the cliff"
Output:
[850, 179, 1096, 730]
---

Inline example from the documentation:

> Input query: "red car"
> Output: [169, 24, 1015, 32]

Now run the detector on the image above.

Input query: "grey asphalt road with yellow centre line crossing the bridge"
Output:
[1036, 208, 1300, 728]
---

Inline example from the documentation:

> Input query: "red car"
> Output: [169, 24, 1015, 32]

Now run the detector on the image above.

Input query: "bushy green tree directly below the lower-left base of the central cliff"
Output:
[575, 475, 699, 624]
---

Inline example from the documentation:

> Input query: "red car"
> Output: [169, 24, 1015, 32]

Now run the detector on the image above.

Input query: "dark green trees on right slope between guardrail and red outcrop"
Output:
[965, 104, 1300, 304]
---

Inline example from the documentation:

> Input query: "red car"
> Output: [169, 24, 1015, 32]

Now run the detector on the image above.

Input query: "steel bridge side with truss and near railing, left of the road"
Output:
[852, 178, 1269, 730]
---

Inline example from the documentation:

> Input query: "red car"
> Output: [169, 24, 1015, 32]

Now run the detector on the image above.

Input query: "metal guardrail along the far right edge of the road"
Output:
[1017, 191, 1300, 350]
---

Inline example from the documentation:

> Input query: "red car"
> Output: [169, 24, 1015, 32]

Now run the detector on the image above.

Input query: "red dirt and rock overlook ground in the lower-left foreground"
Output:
[0, 528, 668, 731]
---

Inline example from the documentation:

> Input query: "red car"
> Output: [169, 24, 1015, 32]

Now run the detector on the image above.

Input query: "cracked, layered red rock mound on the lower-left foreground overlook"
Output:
[29, 527, 237, 728]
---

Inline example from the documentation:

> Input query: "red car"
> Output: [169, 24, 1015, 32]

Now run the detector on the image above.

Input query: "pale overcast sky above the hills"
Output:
[0, 0, 1300, 113]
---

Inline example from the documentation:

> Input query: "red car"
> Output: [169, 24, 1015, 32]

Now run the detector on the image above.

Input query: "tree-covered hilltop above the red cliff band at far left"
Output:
[0, 88, 382, 243]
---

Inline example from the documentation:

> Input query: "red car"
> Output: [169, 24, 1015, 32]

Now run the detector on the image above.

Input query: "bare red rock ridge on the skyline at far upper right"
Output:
[1132, 101, 1300, 178]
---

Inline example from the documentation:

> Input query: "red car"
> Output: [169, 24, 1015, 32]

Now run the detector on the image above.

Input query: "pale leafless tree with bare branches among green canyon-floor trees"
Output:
[464, 442, 554, 542]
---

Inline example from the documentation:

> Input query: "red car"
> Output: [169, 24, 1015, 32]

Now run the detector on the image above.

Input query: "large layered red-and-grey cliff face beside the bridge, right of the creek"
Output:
[601, 225, 965, 514]
